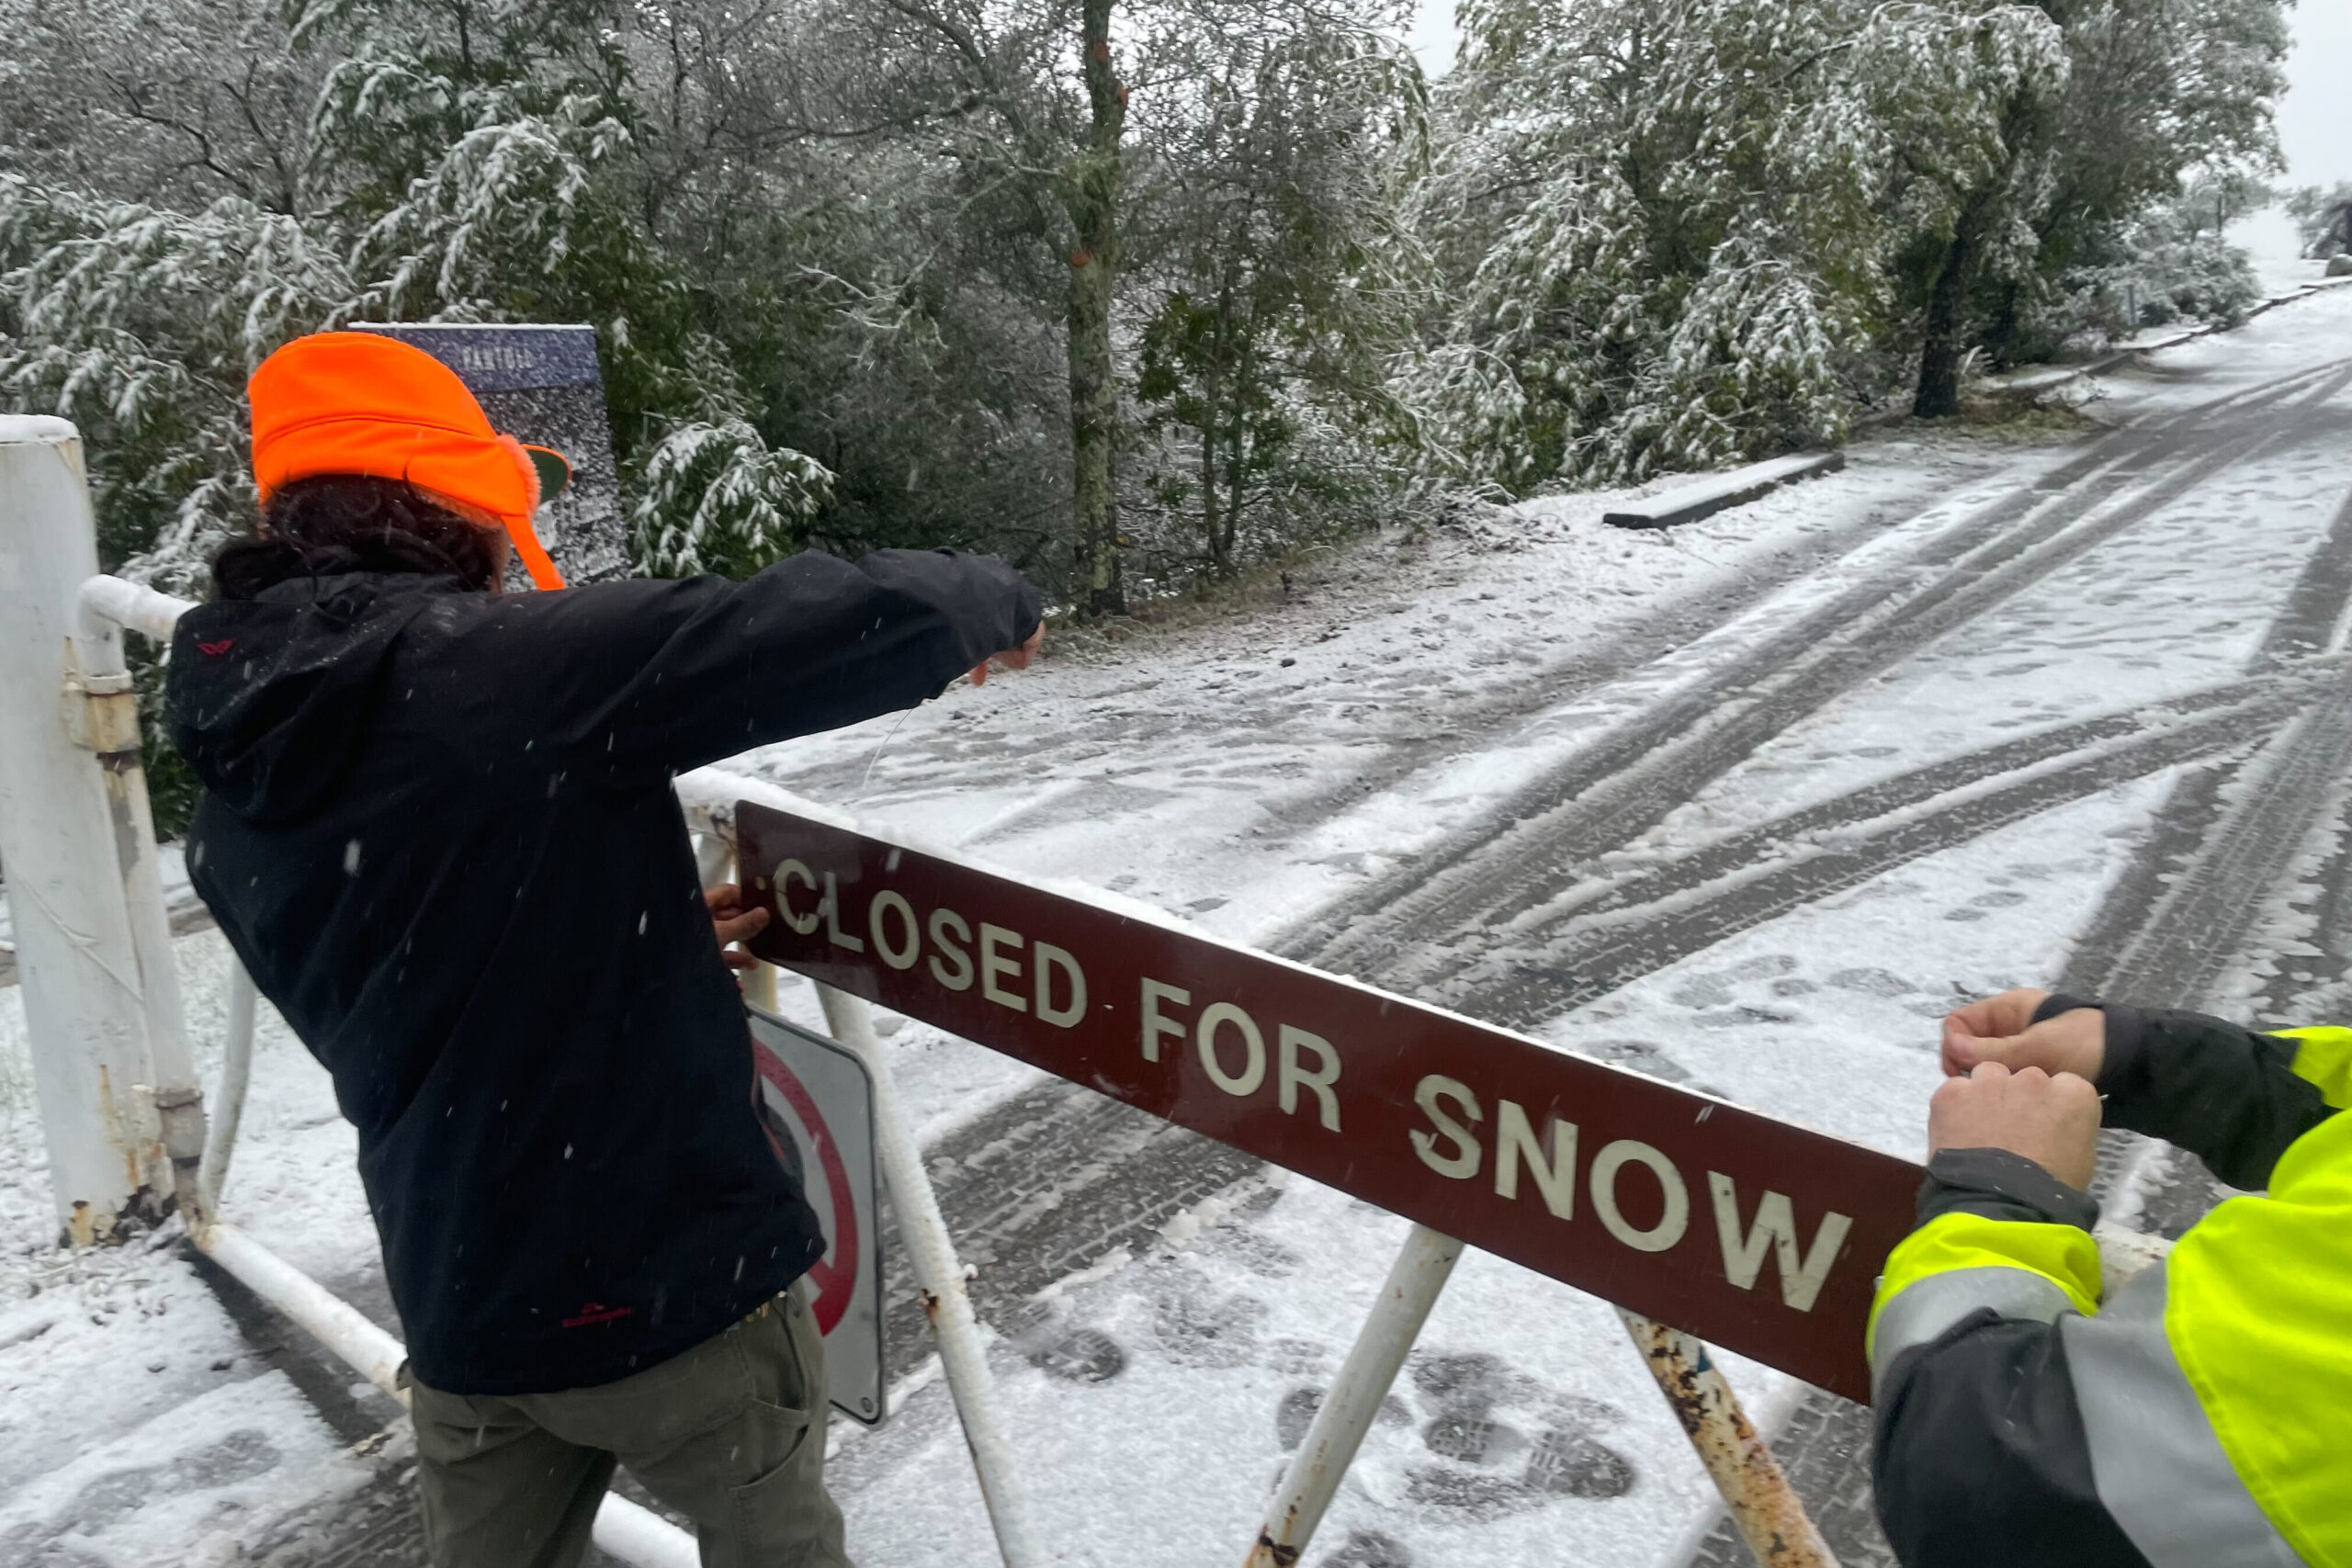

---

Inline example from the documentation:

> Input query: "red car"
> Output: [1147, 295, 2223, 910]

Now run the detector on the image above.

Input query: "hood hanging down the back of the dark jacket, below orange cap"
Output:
[164, 571, 461, 823]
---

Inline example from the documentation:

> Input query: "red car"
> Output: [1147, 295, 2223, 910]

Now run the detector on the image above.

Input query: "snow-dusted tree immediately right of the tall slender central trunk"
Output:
[1131, 3, 1428, 576]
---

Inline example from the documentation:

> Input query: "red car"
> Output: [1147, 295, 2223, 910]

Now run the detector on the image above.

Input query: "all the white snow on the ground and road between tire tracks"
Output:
[0, 291, 2352, 1568]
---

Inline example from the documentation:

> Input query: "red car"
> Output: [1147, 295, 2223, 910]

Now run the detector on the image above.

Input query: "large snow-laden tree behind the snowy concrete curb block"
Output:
[1407, 0, 2065, 491]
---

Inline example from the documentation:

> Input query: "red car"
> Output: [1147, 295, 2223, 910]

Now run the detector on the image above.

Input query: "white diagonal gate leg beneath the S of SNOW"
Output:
[1244, 1224, 1463, 1568]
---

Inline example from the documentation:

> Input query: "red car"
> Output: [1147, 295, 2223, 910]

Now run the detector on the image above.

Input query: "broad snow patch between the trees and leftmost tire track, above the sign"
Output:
[731, 437, 2088, 959]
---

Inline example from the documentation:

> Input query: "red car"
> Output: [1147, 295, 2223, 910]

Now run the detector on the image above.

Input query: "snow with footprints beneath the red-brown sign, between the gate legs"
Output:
[835, 1180, 1708, 1565]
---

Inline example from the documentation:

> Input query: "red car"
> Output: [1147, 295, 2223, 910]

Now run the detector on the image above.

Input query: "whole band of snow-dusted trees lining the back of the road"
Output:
[0, 0, 2314, 611]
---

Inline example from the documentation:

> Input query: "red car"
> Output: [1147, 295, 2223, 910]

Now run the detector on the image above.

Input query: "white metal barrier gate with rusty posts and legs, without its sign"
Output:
[0, 416, 2145, 1568]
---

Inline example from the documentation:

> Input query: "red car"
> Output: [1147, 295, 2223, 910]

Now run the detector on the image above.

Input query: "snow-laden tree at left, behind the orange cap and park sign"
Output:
[0, 0, 823, 588]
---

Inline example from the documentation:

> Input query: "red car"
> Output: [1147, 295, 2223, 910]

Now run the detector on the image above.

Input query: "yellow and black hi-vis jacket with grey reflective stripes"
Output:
[1870, 997, 2352, 1568]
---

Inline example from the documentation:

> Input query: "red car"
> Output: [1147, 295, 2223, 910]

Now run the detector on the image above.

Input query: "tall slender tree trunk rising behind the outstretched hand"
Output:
[1066, 0, 1126, 616]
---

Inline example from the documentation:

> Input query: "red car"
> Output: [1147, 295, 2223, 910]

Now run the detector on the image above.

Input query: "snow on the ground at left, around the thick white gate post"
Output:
[0, 931, 395, 1568]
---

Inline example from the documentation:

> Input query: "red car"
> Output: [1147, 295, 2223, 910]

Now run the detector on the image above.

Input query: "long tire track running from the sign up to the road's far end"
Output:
[1280, 367, 2352, 989]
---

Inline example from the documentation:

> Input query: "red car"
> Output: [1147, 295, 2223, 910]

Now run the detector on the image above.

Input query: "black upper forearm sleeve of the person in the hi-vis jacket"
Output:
[2034, 992, 2334, 1187]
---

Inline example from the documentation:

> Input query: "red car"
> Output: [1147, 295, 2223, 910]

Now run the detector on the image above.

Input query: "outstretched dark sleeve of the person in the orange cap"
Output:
[435, 550, 1042, 785]
